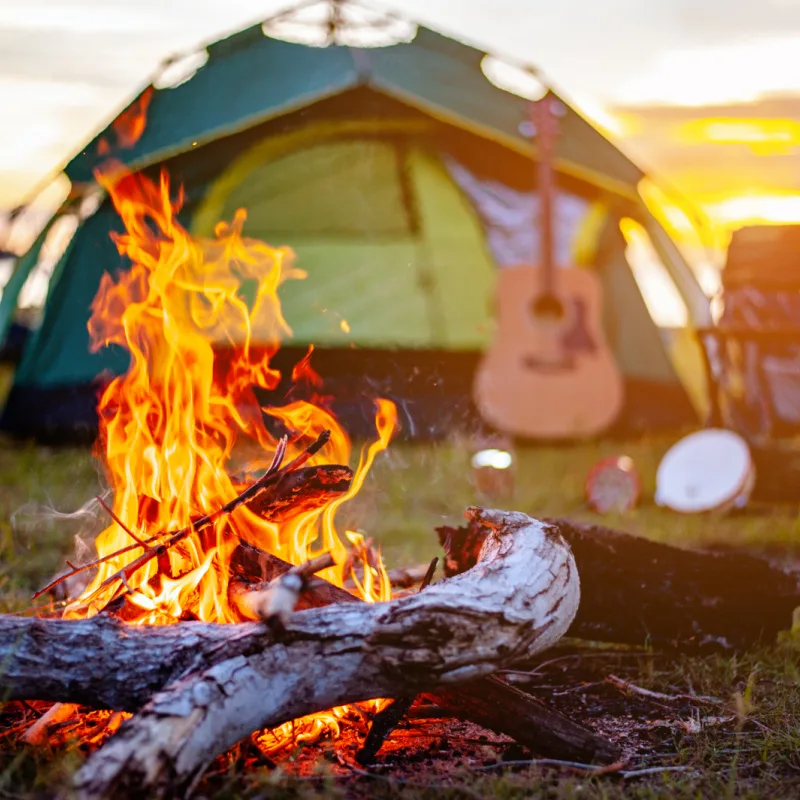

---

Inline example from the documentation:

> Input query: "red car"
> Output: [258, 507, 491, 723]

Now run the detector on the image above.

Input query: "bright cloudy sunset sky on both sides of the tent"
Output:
[0, 0, 800, 228]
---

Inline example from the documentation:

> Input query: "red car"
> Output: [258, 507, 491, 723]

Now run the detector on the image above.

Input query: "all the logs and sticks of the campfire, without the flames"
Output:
[0, 434, 798, 800]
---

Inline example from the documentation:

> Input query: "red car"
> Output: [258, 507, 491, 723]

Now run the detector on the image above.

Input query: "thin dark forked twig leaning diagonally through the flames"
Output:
[33, 430, 324, 601]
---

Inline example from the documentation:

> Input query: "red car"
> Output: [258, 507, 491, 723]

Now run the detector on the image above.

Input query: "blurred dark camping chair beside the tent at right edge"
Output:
[697, 225, 800, 500]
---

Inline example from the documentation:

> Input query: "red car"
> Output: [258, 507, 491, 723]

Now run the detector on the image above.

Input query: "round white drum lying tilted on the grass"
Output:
[655, 428, 754, 513]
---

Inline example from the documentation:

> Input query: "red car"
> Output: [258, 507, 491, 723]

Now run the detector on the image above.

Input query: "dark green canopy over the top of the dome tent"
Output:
[65, 25, 643, 196]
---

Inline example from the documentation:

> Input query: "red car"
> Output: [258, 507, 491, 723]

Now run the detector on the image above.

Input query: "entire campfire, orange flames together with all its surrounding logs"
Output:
[0, 158, 797, 800]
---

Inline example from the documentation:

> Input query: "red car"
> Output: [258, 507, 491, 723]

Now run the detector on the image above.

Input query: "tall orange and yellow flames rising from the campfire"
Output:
[66, 161, 396, 747]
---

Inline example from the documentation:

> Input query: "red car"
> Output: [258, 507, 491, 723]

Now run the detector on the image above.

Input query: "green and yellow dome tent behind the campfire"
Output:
[0, 2, 708, 440]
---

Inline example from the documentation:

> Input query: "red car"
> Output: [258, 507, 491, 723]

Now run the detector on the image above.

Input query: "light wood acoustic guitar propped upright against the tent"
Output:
[473, 92, 623, 440]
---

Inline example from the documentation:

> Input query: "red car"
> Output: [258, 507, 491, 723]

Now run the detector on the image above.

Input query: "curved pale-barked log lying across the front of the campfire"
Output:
[76, 508, 580, 800]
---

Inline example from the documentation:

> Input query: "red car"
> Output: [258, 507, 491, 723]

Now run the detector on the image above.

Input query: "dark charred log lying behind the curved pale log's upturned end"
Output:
[437, 519, 800, 651]
